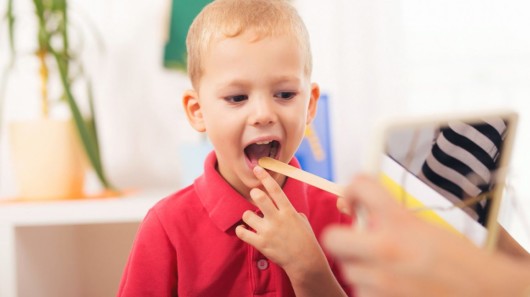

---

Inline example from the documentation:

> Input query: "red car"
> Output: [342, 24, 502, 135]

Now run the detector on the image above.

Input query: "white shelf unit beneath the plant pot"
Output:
[0, 189, 174, 297]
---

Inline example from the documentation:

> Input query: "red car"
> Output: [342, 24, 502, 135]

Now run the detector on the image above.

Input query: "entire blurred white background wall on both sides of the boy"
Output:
[0, 0, 530, 284]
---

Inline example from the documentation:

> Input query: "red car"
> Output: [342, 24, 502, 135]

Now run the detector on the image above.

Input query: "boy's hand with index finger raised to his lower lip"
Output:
[236, 166, 328, 281]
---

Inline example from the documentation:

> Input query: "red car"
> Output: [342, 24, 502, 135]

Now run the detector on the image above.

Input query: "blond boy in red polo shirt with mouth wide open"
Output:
[119, 0, 349, 296]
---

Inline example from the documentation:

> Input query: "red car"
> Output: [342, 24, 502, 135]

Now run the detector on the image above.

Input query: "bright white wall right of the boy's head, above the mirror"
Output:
[297, 0, 530, 249]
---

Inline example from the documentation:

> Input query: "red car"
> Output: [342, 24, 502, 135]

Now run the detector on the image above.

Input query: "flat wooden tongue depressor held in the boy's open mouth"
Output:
[258, 157, 367, 230]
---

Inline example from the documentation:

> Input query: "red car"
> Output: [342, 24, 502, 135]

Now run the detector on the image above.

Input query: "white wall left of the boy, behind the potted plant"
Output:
[0, 0, 198, 196]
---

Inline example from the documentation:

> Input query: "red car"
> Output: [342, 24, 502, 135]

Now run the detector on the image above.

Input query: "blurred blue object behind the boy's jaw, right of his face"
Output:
[295, 94, 334, 181]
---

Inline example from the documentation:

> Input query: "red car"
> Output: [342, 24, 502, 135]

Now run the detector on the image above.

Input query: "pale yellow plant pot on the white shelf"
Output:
[9, 119, 86, 200]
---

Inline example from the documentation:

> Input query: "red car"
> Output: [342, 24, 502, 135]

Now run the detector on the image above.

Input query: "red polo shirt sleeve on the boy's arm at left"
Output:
[118, 209, 178, 297]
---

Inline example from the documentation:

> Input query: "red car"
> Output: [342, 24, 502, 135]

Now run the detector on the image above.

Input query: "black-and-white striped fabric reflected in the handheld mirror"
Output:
[419, 118, 506, 223]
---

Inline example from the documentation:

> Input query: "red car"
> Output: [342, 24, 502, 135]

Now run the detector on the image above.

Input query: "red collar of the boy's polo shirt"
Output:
[194, 151, 309, 232]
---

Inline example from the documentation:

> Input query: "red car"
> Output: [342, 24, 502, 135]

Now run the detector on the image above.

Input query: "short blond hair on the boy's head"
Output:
[186, 0, 312, 88]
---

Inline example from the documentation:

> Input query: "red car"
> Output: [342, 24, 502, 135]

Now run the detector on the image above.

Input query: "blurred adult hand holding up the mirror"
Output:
[323, 176, 530, 297]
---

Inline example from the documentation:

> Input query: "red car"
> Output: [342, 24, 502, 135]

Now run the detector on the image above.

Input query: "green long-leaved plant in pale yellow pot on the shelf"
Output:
[0, 0, 113, 199]
